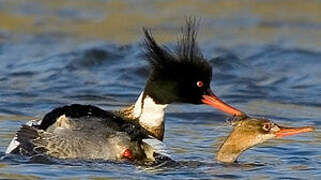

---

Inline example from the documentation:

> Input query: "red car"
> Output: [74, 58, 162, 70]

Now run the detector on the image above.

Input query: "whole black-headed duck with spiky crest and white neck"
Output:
[6, 19, 244, 160]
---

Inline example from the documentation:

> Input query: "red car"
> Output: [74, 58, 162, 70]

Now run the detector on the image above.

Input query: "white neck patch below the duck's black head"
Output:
[133, 92, 167, 127]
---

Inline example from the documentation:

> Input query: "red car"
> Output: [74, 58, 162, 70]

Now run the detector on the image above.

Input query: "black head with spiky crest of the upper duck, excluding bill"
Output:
[144, 18, 212, 104]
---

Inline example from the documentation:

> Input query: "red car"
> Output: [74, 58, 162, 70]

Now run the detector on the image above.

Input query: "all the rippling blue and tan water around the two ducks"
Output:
[0, 0, 321, 179]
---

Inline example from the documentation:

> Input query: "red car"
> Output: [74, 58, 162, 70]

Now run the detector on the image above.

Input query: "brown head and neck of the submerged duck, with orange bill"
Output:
[216, 117, 313, 163]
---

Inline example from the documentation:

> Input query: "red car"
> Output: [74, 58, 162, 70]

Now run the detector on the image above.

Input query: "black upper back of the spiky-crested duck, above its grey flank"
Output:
[39, 104, 146, 139]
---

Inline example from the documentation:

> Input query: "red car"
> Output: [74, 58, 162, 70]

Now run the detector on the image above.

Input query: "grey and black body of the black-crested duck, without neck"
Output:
[10, 104, 148, 160]
